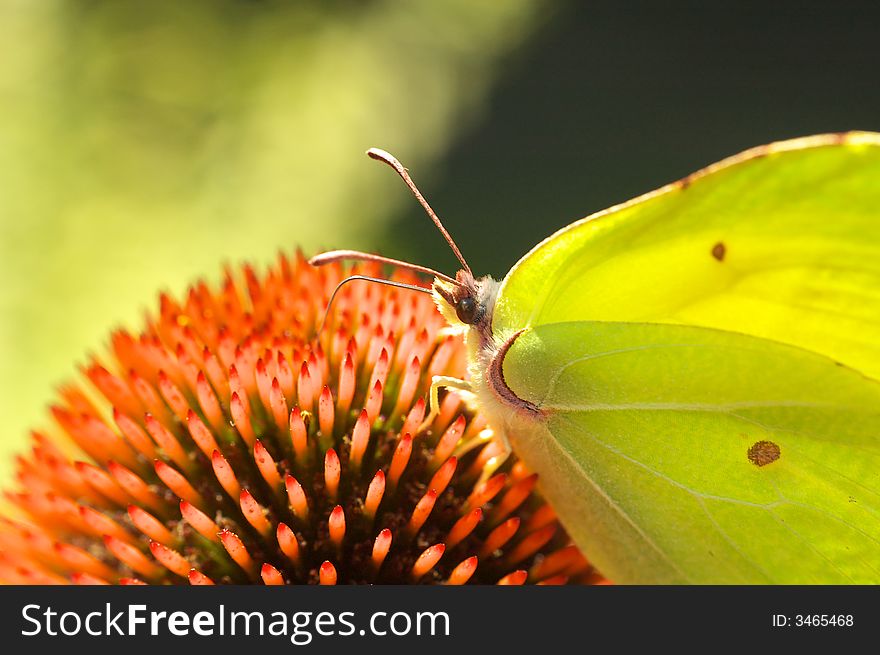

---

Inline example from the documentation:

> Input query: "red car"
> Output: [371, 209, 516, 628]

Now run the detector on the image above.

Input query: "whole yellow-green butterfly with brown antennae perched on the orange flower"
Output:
[312, 132, 880, 584]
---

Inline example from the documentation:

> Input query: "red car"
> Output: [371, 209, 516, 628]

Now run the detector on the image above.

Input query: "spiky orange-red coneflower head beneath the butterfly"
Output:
[0, 256, 603, 585]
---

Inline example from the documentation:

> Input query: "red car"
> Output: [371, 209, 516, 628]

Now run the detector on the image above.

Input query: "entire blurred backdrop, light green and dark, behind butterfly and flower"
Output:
[0, 0, 880, 476]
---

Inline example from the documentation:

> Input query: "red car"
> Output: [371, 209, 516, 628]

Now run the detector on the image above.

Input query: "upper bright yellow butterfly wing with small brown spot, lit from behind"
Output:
[493, 133, 880, 377]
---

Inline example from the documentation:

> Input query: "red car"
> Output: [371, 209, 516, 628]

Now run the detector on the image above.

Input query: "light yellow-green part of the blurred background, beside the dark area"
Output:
[0, 0, 549, 482]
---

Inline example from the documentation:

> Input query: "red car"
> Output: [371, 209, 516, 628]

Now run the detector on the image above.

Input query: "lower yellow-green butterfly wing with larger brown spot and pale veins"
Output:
[504, 321, 880, 583]
